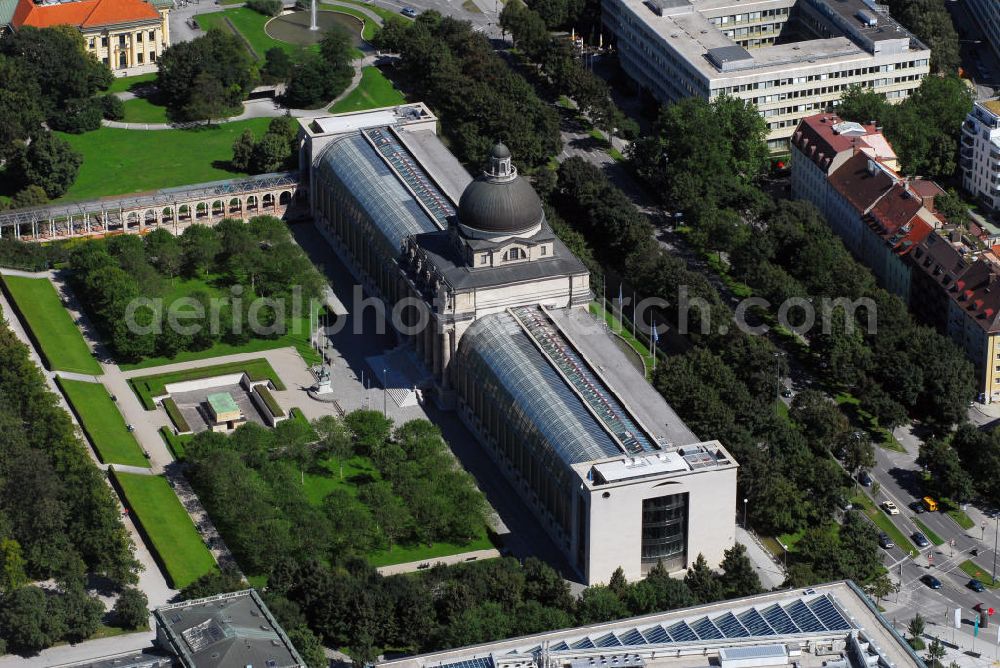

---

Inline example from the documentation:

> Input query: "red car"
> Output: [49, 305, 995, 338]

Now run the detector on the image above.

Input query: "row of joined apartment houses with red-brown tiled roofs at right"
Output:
[791, 114, 1000, 401]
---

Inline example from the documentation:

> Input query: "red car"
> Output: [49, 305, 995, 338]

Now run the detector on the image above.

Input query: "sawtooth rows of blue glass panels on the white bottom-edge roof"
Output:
[439, 595, 854, 668]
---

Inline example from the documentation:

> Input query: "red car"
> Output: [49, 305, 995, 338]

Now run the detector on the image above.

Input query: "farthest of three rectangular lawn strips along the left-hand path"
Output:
[3, 276, 103, 376]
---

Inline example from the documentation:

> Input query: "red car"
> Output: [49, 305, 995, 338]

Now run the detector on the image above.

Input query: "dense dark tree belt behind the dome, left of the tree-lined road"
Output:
[375, 11, 560, 168]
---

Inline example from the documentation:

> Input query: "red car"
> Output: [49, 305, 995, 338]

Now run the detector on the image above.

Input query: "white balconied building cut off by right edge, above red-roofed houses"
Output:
[959, 100, 1000, 211]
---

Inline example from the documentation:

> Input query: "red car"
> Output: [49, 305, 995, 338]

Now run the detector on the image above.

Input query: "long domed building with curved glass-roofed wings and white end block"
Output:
[299, 104, 737, 583]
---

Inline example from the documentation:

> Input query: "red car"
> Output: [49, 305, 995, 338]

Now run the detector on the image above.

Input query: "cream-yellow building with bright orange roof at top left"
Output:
[8, 0, 173, 76]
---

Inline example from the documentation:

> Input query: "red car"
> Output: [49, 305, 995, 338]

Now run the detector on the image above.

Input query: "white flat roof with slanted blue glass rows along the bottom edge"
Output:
[378, 581, 926, 668]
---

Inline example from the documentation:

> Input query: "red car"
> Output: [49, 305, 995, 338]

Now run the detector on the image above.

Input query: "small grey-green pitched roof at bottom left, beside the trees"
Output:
[153, 589, 305, 668]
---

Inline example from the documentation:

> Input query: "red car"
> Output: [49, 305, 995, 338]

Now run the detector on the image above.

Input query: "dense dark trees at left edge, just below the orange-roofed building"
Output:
[0, 26, 121, 207]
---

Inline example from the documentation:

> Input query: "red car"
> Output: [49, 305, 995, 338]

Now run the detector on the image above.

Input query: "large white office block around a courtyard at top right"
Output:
[602, 0, 930, 151]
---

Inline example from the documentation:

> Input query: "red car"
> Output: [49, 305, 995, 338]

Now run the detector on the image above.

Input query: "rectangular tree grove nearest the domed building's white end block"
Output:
[186, 411, 487, 574]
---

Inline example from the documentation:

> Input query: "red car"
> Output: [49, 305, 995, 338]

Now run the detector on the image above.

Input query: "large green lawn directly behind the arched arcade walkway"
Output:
[56, 118, 271, 202]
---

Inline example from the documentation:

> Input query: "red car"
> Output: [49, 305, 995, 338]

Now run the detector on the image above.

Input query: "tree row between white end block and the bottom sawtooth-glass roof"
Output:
[258, 545, 761, 661]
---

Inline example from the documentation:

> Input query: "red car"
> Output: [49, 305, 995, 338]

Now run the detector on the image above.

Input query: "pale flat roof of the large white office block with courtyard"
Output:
[619, 0, 923, 81]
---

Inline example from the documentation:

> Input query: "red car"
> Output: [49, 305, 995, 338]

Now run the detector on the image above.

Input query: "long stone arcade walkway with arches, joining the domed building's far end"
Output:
[0, 172, 301, 241]
